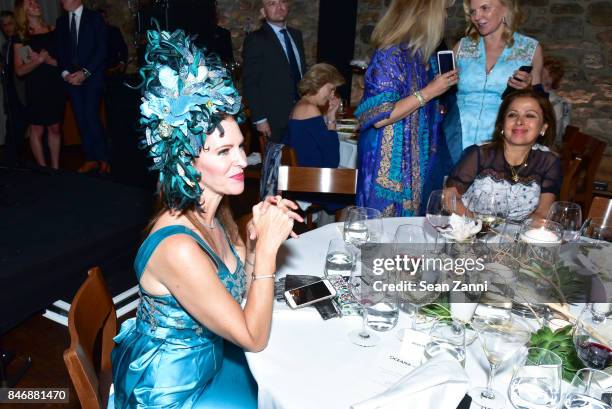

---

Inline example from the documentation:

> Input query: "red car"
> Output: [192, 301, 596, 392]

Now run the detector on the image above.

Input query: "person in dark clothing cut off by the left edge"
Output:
[0, 11, 27, 166]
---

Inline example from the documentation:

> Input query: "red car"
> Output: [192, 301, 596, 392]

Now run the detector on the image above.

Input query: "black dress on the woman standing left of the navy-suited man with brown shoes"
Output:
[16, 31, 66, 125]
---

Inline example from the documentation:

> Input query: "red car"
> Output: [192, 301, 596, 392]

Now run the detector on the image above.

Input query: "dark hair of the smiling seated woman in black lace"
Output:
[490, 88, 557, 150]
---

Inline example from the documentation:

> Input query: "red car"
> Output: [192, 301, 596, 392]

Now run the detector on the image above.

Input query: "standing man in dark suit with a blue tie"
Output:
[242, 0, 306, 142]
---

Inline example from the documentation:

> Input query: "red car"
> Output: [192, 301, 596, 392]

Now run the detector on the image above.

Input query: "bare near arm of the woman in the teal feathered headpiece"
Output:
[148, 204, 293, 351]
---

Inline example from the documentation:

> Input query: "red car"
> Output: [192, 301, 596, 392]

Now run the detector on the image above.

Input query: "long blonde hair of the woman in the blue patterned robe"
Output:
[371, 0, 449, 62]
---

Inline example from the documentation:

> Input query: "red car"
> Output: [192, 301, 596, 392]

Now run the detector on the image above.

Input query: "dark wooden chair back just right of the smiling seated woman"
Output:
[561, 127, 607, 211]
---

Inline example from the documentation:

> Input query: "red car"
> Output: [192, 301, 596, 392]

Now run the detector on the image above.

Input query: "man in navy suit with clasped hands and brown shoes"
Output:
[56, 0, 110, 173]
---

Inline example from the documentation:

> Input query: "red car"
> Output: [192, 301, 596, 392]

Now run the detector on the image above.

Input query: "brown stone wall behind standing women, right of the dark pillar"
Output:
[355, 0, 612, 185]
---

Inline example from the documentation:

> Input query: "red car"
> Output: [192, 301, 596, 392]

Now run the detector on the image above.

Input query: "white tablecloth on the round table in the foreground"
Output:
[246, 218, 536, 409]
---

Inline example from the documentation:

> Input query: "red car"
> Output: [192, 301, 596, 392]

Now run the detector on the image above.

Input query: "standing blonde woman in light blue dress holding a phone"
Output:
[445, 0, 543, 162]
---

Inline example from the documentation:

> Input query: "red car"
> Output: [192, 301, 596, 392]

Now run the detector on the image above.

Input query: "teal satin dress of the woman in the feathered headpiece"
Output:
[112, 225, 257, 409]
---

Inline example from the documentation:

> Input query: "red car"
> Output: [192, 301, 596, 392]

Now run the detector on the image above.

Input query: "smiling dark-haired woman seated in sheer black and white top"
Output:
[446, 90, 562, 220]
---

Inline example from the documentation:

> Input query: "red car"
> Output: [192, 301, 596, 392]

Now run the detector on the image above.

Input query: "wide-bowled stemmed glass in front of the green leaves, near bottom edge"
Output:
[469, 315, 531, 409]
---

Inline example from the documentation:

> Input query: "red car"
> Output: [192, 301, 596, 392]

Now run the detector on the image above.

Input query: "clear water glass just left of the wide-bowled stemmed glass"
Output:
[425, 321, 465, 367]
